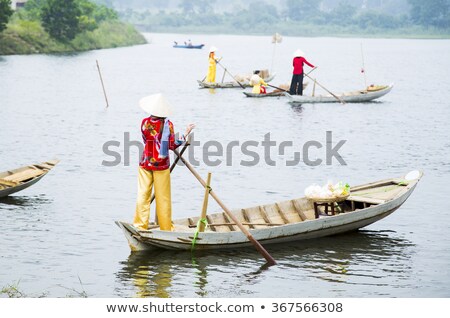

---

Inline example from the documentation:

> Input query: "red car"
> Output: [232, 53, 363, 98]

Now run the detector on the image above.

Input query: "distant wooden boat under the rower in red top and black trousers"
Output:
[286, 84, 394, 104]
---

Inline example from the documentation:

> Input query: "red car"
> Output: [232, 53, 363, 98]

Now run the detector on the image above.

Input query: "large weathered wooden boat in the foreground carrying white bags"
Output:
[116, 171, 422, 251]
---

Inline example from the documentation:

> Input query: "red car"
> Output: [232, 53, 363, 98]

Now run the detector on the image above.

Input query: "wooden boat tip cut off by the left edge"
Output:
[0, 160, 59, 198]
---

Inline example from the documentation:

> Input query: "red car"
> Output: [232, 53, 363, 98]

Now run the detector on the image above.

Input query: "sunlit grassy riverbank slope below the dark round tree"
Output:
[0, 19, 146, 55]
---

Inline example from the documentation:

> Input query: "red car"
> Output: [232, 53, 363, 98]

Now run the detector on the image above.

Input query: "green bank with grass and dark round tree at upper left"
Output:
[0, 0, 146, 55]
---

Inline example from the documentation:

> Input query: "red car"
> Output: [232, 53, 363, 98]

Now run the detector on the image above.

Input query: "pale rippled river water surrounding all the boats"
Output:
[0, 34, 450, 297]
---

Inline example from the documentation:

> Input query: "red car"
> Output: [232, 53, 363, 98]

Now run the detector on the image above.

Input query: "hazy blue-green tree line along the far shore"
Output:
[116, 0, 450, 34]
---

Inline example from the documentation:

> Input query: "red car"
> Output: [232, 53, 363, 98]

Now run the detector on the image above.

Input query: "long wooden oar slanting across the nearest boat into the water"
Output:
[173, 149, 276, 265]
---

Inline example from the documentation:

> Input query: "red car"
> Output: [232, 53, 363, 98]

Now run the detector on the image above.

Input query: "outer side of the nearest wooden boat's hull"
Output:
[116, 173, 418, 251]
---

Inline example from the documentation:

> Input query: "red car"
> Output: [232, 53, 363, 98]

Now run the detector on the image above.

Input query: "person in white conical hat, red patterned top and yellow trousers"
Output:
[133, 94, 194, 231]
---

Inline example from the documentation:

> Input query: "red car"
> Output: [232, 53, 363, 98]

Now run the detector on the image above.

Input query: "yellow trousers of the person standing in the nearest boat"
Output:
[133, 167, 173, 231]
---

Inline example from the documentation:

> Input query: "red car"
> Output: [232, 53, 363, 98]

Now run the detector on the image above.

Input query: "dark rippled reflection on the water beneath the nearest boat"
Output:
[116, 230, 414, 298]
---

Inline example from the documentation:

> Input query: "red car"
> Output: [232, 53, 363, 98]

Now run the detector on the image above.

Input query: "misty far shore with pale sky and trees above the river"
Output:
[91, 0, 450, 37]
